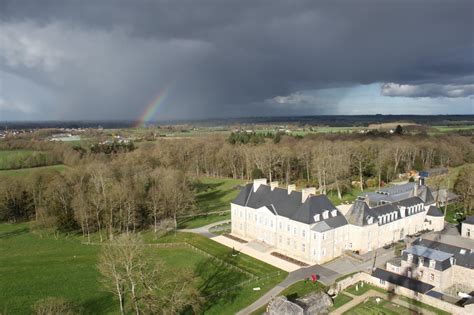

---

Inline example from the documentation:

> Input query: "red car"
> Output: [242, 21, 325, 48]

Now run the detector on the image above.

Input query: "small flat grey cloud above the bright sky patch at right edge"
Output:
[381, 83, 474, 98]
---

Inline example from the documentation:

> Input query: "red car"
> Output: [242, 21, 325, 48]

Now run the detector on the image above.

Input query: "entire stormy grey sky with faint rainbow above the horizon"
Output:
[0, 0, 474, 121]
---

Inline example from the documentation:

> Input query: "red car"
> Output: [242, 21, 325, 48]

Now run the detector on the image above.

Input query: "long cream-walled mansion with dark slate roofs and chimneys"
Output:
[231, 179, 444, 264]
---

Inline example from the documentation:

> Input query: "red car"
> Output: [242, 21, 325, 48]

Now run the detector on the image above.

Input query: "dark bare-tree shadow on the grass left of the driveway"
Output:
[195, 258, 248, 312]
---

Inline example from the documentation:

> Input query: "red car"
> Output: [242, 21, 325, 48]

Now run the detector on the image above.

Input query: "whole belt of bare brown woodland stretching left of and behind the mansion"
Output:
[0, 134, 474, 239]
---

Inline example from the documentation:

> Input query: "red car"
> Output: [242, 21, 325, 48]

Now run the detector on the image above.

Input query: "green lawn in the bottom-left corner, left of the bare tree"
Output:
[0, 224, 117, 314]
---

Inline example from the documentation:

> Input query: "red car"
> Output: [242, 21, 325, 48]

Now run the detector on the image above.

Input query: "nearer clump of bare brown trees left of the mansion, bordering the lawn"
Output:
[0, 158, 194, 240]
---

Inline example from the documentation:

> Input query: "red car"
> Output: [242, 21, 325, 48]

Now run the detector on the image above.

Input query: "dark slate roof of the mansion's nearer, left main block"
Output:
[232, 184, 347, 228]
